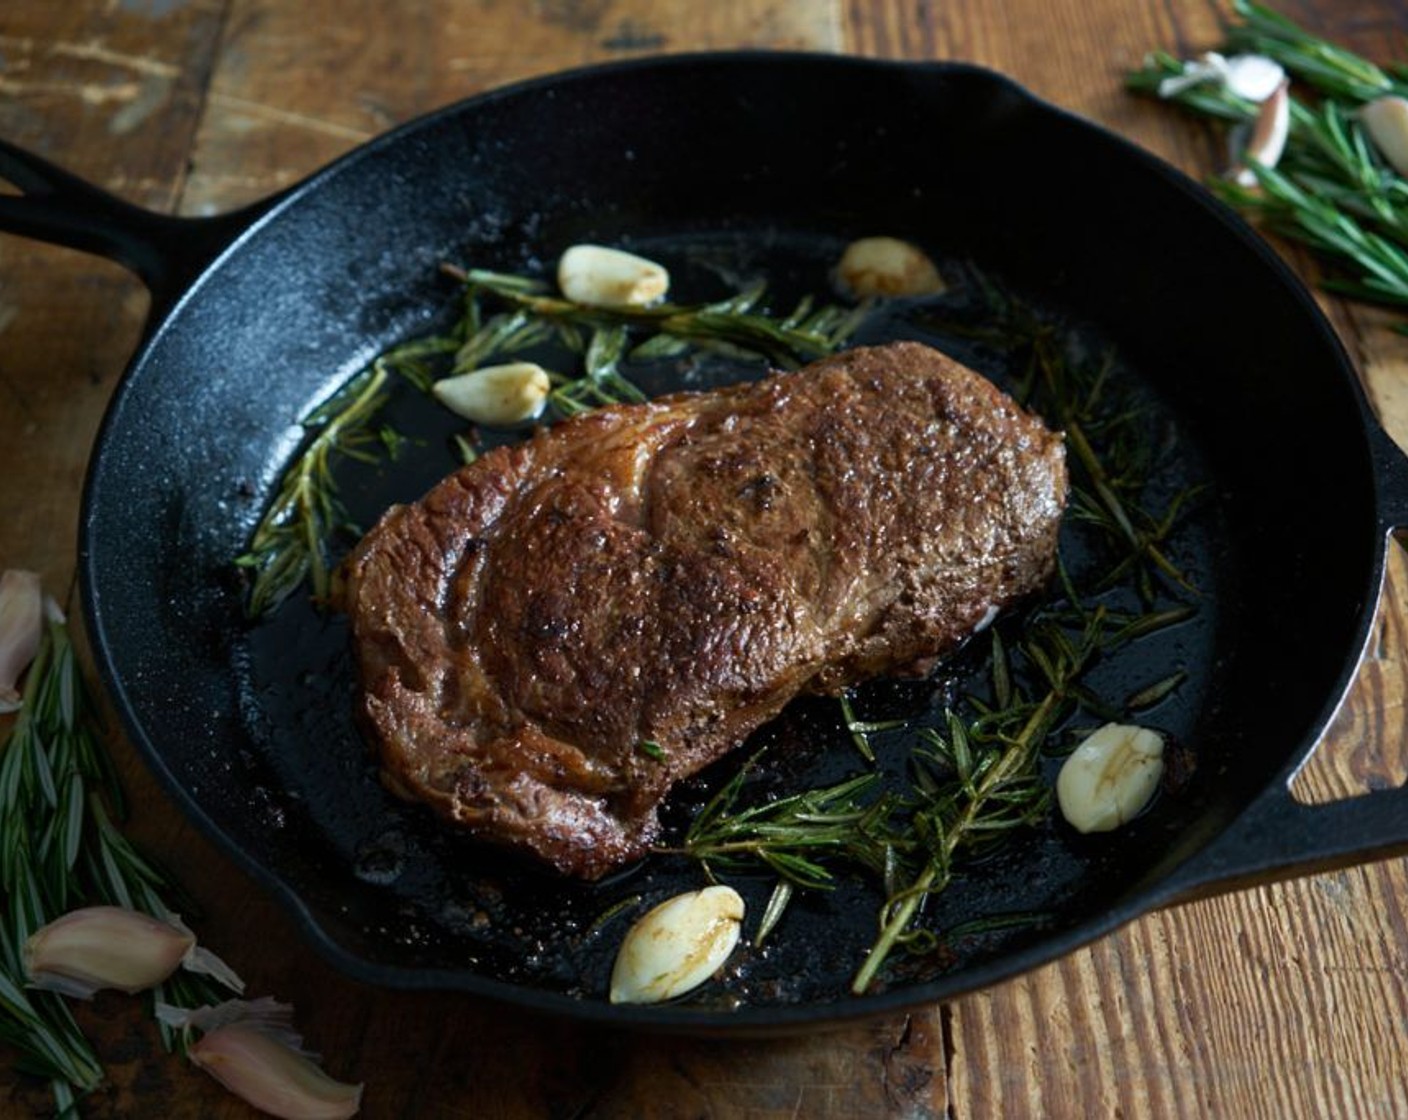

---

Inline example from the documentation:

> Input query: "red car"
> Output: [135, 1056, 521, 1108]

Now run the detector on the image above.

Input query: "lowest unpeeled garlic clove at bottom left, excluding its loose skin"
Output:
[186, 1021, 362, 1120]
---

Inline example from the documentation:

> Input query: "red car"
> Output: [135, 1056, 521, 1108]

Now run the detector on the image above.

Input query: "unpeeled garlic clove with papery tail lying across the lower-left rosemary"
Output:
[21, 906, 244, 999]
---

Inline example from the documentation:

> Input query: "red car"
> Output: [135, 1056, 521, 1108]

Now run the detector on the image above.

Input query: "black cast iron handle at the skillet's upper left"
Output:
[0, 139, 275, 323]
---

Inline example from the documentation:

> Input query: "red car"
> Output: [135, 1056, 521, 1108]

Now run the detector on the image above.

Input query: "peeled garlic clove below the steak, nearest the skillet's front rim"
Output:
[611, 886, 743, 1003]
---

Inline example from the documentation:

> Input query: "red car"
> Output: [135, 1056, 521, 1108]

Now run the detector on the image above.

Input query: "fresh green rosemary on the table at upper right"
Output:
[1128, 0, 1408, 330]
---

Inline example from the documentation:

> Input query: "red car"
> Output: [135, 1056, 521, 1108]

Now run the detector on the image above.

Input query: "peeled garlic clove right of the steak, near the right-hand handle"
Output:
[1056, 723, 1163, 833]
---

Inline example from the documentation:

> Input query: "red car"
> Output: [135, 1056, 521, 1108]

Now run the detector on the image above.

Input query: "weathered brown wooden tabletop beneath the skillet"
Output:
[0, 0, 1408, 1120]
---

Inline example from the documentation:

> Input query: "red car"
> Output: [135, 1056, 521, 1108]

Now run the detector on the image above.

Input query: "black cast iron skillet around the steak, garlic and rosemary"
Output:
[0, 54, 1408, 1031]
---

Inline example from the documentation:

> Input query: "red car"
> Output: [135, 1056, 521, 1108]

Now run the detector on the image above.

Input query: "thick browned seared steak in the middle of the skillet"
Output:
[342, 342, 1066, 879]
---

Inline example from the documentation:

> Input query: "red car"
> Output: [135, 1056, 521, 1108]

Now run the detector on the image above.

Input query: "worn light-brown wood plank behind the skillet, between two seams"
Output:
[183, 0, 841, 213]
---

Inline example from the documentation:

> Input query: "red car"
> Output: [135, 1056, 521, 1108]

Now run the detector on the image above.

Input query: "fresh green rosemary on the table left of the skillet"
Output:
[0, 621, 221, 1114]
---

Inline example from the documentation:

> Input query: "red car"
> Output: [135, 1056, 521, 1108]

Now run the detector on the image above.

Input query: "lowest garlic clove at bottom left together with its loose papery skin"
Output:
[156, 997, 362, 1120]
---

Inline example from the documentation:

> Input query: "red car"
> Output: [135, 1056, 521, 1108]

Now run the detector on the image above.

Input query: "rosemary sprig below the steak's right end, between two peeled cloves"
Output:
[679, 604, 1186, 993]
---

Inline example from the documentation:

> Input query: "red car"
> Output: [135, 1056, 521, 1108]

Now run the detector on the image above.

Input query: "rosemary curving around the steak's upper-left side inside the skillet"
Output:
[235, 263, 869, 618]
